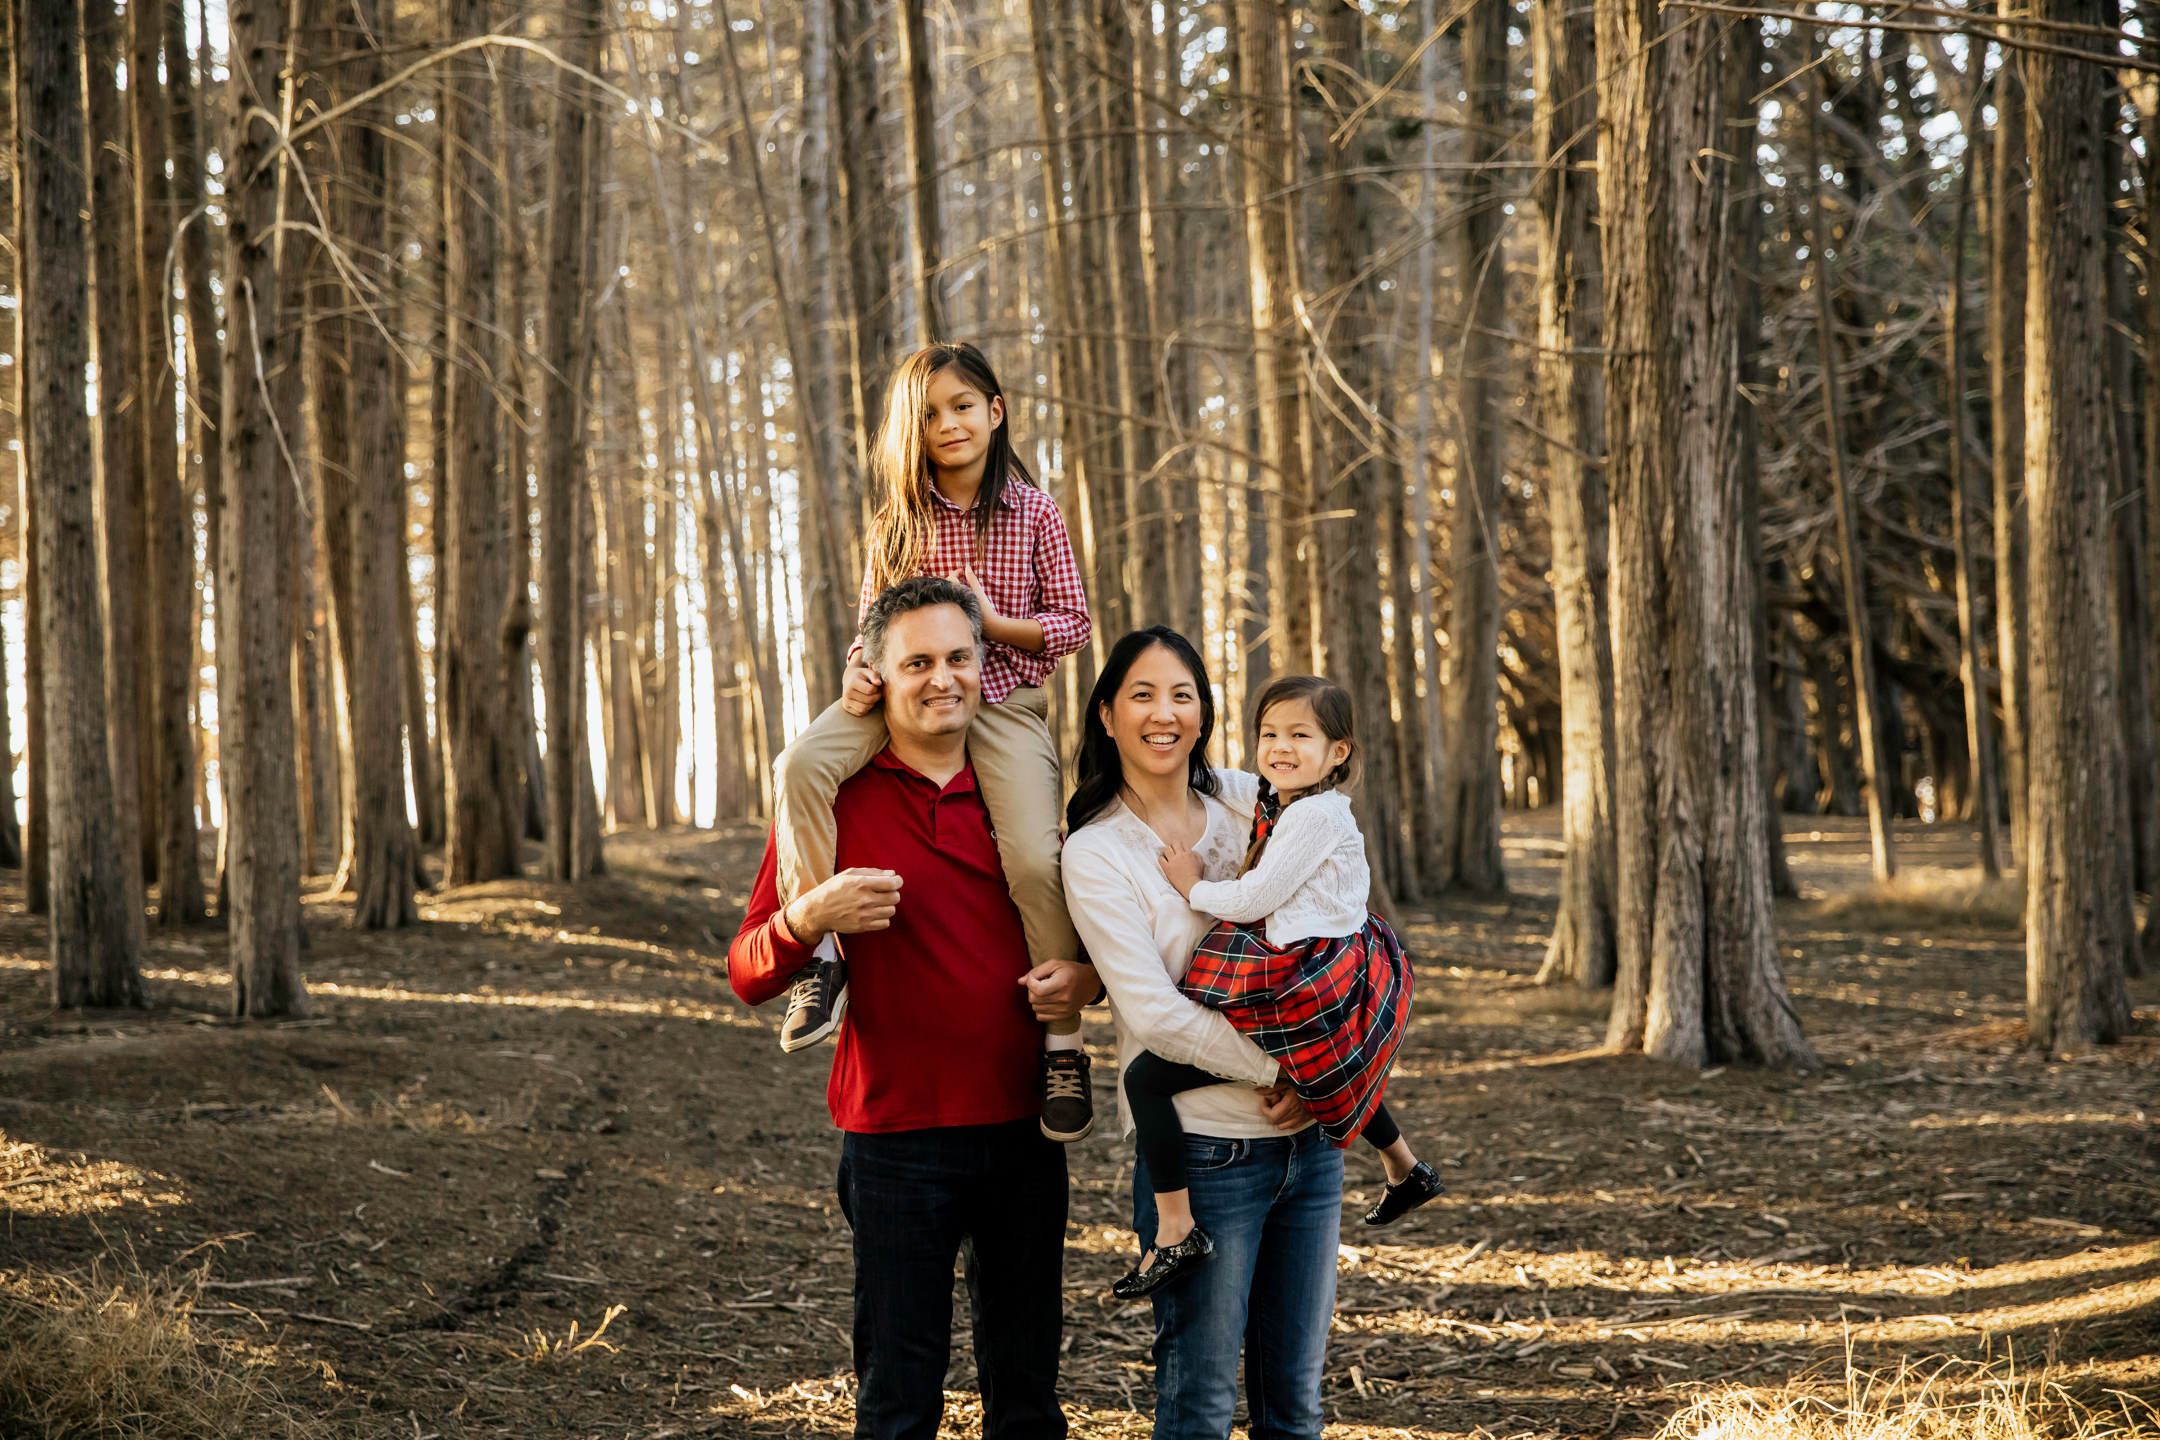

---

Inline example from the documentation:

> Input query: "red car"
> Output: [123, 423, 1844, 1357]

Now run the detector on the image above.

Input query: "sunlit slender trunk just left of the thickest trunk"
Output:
[1531, 0, 1618, 989]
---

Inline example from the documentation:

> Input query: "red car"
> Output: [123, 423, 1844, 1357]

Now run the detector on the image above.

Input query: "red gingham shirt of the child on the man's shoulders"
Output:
[855, 479, 1095, 704]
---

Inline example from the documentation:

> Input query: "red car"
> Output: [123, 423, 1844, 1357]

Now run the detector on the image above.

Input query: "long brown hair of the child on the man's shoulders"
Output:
[870, 341, 1035, 589]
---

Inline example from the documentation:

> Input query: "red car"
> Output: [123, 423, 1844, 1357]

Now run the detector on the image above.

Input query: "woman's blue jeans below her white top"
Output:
[1132, 1125, 1344, 1440]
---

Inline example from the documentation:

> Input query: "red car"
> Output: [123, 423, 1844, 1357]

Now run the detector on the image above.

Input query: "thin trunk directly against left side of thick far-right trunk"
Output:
[1987, 50, 2033, 867]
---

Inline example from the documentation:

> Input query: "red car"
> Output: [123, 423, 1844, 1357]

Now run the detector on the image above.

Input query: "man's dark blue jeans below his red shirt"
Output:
[838, 1116, 1067, 1440]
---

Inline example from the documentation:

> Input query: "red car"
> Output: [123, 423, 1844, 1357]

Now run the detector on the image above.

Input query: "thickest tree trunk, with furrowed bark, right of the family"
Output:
[1596, 0, 1812, 1064]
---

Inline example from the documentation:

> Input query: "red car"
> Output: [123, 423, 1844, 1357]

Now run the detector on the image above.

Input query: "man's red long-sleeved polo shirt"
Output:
[728, 749, 1043, 1133]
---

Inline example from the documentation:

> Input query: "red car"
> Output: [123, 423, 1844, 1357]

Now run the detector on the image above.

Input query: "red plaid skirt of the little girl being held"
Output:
[1179, 915, 1410, 1146]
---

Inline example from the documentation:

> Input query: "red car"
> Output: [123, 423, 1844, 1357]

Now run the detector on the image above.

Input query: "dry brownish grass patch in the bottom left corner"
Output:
[0, 1269, 330, 1440]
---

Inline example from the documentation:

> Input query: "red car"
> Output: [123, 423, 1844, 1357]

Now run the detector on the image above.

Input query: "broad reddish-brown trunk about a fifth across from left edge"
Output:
[436, 0, 525, 885]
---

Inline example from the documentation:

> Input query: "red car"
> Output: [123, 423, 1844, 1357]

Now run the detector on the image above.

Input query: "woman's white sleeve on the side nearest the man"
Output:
[1063, 842, 1281, 1086]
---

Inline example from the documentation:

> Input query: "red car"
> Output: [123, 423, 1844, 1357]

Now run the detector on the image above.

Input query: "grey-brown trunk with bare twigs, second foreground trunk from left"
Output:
[218, 0, 309, 1015]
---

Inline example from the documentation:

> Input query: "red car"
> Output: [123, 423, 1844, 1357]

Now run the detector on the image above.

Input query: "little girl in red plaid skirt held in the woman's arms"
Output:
[1115, 676, 1441, 1300]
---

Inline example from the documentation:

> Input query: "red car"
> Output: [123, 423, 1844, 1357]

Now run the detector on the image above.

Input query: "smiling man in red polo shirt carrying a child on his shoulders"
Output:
[728, 576, 1097, 1440]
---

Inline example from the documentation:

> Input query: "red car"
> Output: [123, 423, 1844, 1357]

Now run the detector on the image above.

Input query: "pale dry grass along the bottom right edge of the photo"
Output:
[1659, 1360, 2160, 1440]
